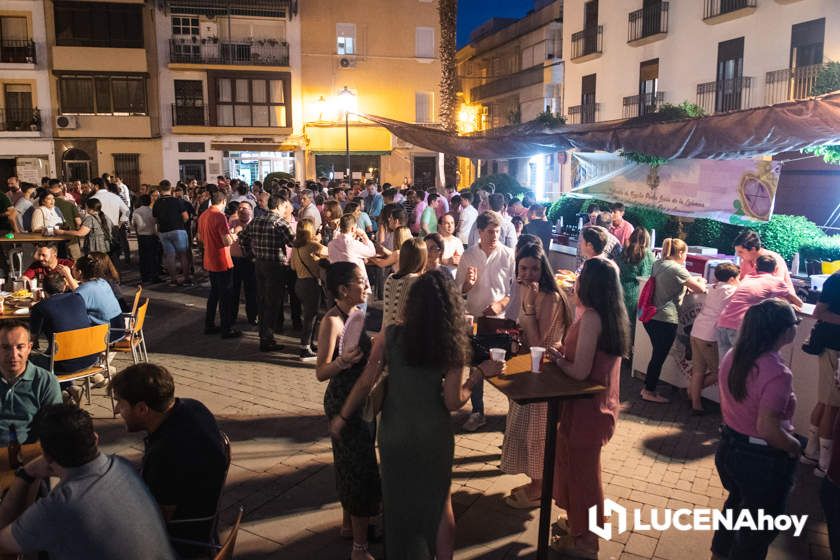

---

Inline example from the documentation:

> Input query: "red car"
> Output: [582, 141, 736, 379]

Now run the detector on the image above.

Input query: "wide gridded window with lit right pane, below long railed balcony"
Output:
[215, 76, 290, 128]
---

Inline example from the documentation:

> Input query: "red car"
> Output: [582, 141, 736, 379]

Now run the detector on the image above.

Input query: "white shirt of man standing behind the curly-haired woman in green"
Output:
[455, 243, 516, 317]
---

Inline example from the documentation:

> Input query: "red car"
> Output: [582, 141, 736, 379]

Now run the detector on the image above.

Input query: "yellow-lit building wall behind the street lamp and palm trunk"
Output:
[300, 0, 440, 183]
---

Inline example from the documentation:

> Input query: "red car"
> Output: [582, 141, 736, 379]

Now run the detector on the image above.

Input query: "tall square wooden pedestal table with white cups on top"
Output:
[487, 354, 607, 560]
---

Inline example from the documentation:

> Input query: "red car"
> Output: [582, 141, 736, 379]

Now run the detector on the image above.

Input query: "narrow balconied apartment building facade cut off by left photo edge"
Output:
[0, 0, 56, 182]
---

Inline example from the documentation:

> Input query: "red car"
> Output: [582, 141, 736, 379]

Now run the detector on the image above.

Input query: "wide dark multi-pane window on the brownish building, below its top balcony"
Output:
[58, 75, 147, 115]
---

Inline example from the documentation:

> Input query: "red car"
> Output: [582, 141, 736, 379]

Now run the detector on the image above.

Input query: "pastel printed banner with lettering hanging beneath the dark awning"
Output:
[570, 152, 781, 224]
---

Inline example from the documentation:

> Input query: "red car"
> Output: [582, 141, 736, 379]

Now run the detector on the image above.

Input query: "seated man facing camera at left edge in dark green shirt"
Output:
[0, 320, 61, 445]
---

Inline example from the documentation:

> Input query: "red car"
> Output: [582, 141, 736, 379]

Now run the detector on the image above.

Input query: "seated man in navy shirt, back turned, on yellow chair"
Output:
[29, 273, 104, 383]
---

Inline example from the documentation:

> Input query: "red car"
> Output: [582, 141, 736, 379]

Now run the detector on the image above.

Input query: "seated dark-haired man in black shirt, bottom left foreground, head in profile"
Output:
[111, 363, 228, 558]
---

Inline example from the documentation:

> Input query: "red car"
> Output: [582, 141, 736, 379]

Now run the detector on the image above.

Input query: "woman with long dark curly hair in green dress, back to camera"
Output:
[331, 270, 504, 560]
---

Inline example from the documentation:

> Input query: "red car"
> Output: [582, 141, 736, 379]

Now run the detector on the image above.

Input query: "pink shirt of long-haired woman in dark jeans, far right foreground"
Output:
[719, 350, 796, 438]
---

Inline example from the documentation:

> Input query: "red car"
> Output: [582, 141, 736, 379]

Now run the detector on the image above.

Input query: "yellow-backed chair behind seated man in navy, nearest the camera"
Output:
[50, 323, 117, 417]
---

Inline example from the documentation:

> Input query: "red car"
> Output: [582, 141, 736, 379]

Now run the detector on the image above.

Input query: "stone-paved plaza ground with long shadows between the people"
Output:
[82, 276, 830, 560]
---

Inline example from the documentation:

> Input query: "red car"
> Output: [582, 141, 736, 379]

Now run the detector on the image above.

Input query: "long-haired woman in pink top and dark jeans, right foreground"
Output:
[712, 298, 802, 559]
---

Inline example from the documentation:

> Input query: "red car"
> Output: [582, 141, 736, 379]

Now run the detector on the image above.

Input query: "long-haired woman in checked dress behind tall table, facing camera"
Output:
[501, 243, 572, 509]
